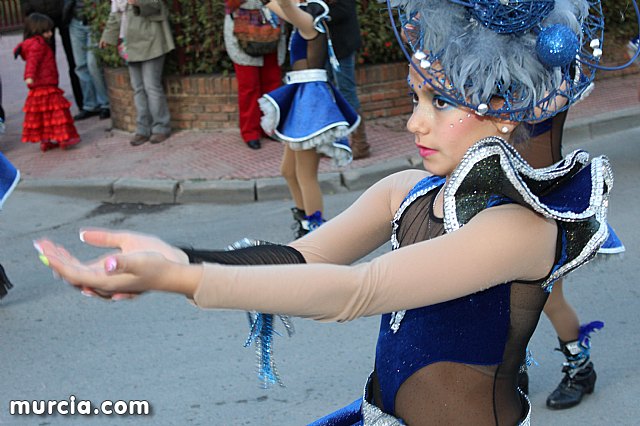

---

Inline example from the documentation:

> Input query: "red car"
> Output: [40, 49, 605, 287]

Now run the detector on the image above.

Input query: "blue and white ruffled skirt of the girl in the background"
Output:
[258, 69, 360, 166]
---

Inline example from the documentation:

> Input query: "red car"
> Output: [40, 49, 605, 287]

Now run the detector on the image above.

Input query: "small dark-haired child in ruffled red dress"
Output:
[13, 13, 80, 152]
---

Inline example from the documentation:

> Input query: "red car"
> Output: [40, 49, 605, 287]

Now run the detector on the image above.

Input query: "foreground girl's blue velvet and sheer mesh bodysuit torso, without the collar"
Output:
[371, 178, 547, 424]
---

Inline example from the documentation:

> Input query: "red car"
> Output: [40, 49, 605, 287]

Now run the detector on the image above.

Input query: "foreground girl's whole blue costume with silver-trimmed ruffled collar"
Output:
[313, 138, 612, 426]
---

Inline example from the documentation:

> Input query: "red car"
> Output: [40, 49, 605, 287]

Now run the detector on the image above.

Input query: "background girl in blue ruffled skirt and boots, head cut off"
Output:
[259, 0, 360, 237]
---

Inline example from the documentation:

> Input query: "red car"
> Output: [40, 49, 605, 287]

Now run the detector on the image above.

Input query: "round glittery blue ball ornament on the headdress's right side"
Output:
[536, 24, 580, 68]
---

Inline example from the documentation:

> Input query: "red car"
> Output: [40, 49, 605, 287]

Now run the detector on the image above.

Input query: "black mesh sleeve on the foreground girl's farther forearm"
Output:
[180, 244, 306, 265]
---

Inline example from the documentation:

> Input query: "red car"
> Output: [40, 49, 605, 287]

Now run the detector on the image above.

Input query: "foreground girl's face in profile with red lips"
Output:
[407, 66, 505, 176]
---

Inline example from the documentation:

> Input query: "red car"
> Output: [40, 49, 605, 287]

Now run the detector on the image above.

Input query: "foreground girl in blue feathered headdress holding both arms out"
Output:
[36, 0, 640, 425]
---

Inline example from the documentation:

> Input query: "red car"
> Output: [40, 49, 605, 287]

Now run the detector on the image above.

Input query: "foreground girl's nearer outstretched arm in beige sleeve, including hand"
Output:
[37, 198, 557, 321]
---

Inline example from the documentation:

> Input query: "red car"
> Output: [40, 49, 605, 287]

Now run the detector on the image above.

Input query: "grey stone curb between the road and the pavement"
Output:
[17, 106, 640, 204]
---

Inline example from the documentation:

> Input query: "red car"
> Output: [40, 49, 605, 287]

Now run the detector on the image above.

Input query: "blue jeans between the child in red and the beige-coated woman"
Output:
[69, 18, 109, 111]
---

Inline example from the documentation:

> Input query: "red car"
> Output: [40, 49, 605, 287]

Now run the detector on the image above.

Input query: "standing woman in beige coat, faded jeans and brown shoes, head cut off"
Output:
[99, 0, 175, 146]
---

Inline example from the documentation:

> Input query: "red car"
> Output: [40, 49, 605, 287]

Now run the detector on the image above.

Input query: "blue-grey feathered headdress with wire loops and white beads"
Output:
[387, 0, 639, 122]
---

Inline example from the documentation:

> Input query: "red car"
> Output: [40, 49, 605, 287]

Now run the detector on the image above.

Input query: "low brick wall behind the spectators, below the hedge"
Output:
[100, 62, 411, 132]
